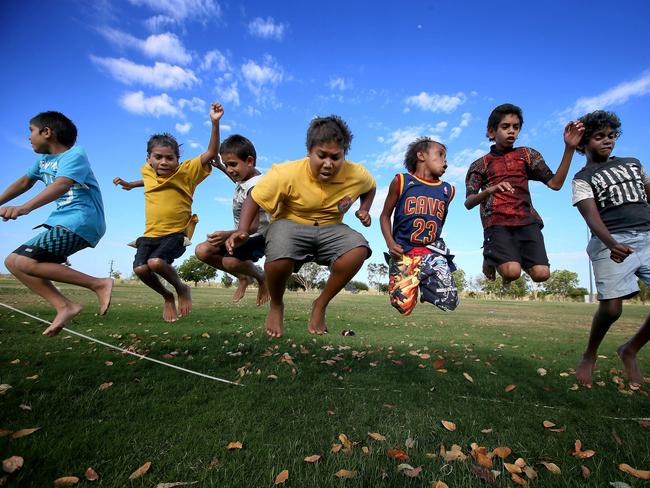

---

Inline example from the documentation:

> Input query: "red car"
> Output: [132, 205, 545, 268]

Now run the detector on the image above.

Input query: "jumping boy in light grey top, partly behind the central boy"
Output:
[194, 134, 269, 305]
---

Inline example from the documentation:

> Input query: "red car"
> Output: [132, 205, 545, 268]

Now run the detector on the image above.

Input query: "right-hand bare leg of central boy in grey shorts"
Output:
[307, 246, 368, 335]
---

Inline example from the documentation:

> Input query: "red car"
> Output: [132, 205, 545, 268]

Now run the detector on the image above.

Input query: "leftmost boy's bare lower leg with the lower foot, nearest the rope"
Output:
[5, 253, 81, 337]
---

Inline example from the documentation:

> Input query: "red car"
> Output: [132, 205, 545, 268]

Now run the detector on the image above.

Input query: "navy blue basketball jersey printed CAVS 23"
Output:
[393, 173, 456, 252]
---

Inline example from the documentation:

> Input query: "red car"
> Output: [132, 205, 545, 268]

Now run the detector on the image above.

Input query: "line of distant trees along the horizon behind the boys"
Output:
[112, 256, 650, 303]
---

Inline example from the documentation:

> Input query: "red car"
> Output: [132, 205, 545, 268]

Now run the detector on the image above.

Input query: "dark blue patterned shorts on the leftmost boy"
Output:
[14, 226, 90, 263]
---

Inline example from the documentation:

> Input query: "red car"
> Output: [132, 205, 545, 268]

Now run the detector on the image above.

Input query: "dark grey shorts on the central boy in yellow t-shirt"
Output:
[265, 219, 372, 271]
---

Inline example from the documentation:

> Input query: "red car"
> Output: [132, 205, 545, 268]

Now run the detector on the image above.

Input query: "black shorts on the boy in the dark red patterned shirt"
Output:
[483, 223, 549, 269]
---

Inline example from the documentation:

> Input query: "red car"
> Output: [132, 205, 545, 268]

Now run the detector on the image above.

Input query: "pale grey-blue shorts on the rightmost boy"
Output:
[587, 230, 650, 300]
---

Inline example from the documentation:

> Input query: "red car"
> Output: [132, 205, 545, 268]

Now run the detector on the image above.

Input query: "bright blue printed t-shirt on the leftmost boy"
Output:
[27, 146, 106, 247]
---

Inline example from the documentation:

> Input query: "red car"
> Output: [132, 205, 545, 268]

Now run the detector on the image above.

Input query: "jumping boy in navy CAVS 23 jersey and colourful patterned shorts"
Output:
[380, 137, 458, 315]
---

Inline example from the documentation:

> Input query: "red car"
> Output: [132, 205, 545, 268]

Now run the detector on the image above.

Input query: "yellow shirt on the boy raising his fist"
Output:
[140, 156, 212, 238]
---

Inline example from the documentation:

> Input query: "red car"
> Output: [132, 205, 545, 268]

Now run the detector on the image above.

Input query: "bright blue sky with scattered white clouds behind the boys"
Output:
[0, 0, 650, 286]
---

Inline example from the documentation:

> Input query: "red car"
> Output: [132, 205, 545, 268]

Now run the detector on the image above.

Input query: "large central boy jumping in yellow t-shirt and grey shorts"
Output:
[226, 115, 375, 337]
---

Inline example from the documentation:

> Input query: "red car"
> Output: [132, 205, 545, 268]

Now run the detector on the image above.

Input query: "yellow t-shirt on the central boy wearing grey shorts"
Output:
[251, 158, 375, 225]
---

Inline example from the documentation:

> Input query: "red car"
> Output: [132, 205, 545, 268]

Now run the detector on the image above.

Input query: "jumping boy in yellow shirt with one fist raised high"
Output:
[113, 102, 223, 322]
